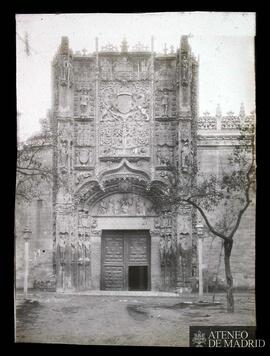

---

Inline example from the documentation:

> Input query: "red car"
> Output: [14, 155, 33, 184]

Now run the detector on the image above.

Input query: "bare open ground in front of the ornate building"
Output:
[16, 292, 255, 346]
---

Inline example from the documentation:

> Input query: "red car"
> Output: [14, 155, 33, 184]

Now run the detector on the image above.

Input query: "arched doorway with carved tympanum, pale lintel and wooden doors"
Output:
[86, 192, 159, 290]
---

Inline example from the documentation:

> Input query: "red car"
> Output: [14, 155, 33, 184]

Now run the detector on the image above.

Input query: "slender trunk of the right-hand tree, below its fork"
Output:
[224, 240, 234, 313]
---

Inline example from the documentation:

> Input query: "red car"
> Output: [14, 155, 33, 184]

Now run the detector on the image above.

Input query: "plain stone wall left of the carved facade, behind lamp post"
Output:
[15, 150, 54, 289]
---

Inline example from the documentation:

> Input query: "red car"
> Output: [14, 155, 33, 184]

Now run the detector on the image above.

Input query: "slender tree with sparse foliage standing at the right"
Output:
[153, 124, 256, 312]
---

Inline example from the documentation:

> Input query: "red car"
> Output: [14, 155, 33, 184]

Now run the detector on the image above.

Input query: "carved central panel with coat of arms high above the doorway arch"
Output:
[99, 82, 150, 158]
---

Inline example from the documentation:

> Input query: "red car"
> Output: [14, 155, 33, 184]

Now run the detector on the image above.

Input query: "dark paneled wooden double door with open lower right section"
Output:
[101, 230, 151, 290]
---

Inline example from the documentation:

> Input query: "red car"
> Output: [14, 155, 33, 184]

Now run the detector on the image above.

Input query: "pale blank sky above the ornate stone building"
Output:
[16, 12, 255, 140]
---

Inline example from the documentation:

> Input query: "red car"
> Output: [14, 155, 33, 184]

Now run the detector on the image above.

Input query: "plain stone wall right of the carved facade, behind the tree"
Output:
[198, 147, 255, 289]
